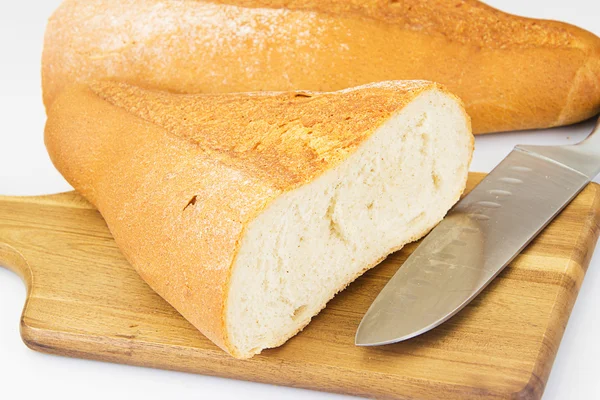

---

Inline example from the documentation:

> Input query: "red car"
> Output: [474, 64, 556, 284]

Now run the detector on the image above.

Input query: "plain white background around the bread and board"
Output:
[0, 0, 600, 400]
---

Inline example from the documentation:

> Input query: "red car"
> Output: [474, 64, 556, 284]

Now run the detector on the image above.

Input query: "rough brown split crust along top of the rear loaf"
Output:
[210, 0, 586, 48]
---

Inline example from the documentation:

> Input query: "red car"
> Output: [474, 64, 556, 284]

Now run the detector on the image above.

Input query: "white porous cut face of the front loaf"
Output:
[225, 90, 473, 358]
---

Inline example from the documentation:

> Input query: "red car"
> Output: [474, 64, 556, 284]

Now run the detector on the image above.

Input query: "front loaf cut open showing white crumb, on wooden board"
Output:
[46, 81, 473, 358]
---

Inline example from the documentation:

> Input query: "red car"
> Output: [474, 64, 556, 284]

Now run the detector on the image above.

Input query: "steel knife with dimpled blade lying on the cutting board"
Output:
[355, 116, 600, 346]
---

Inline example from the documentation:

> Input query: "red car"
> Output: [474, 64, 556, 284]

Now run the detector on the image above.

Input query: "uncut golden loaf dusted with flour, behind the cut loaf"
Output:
[43, 0, 600, 133]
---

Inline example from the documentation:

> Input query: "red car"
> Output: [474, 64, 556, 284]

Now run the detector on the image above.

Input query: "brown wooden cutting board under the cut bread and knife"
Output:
[0, 174, 600, 400]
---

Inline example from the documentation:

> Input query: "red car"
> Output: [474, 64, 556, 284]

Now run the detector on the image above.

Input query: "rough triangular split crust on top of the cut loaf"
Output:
[90, 81, 431, 190]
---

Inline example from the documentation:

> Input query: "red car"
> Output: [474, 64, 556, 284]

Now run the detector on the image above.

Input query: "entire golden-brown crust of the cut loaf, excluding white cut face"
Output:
[45, 82, 460, 356]
